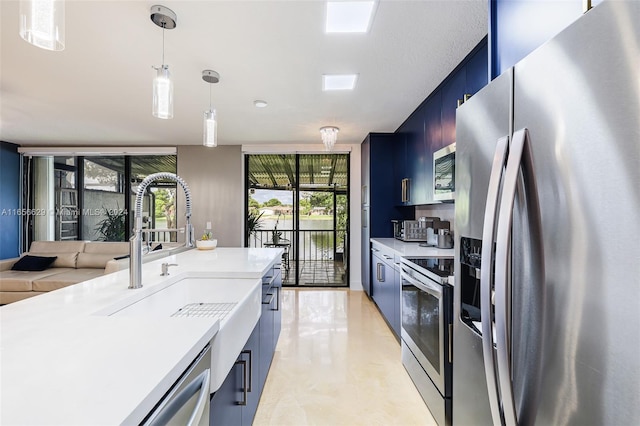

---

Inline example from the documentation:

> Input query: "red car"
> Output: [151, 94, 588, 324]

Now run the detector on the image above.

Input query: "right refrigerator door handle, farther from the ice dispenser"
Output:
[495, 129, 544, 425]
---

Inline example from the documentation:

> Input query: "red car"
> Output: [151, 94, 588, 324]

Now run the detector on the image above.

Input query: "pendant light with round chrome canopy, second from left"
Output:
[151, 5, 177, 119]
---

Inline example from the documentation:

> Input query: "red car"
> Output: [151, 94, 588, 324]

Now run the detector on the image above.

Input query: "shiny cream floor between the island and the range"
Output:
[253, 288, 436, 426]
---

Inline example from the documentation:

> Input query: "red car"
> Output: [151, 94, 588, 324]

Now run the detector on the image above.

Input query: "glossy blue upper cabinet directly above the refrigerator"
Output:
[489, 0, 602, 79]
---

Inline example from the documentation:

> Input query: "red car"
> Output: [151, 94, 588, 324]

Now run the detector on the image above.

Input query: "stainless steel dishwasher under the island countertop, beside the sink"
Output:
[142, 345, 211, 426]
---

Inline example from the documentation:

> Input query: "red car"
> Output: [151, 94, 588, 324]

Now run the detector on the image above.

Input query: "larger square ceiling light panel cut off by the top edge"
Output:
[325, 1, 375, 33]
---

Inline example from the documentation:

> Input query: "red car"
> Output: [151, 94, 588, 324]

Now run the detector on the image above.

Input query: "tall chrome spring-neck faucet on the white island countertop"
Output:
[129, 173, 194, 289]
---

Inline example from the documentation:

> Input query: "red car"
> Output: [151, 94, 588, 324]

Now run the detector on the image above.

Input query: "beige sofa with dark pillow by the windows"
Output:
[0, 241, 129, 305]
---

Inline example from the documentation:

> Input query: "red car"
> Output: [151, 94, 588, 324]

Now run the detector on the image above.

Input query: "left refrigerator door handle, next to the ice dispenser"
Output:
[480, 136, 509, 426]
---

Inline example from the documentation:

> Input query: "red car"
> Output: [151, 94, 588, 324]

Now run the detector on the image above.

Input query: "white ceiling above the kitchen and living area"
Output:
[0, 0, 488, 148]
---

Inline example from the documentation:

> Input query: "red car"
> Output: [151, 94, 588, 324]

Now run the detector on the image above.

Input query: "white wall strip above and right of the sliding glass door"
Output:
[242, 144, 362, 291]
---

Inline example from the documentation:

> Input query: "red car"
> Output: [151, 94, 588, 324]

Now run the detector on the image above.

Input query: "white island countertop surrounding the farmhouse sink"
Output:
[0, 248, 282, 425]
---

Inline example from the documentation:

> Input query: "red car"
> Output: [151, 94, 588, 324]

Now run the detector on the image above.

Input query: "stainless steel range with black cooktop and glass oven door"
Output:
[400, 257, 453, 426]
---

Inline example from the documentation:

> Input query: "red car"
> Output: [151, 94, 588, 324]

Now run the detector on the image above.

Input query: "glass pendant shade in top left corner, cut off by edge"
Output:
[20, 0, 64, 50]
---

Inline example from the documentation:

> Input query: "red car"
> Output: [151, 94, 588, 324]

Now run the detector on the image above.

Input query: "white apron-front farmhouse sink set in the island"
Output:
[103, 277, 262, 393]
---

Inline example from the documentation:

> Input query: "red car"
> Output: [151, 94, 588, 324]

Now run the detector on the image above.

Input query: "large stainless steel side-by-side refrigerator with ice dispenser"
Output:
[452, 1, 640, 425]
